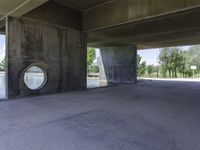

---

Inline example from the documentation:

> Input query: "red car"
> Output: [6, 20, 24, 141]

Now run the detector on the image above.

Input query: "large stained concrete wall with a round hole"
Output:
[7, 17, 86, 98]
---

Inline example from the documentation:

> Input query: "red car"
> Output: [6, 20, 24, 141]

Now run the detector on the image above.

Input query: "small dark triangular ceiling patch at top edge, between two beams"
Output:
[55, 0, 113, 11]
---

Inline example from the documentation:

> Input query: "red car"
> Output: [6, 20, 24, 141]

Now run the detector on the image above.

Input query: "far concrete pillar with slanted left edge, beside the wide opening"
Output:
[100, 46, 137, 83]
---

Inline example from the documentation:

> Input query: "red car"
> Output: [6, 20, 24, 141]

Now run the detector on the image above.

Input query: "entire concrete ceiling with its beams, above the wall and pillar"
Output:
[0, 0, 200, 49]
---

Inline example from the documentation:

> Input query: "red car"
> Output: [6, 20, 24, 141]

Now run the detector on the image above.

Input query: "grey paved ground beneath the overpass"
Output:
[0, 81, 200, 150]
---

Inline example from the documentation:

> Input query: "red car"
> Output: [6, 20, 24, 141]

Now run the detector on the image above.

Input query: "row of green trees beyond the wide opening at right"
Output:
[137, 45, 200, 78]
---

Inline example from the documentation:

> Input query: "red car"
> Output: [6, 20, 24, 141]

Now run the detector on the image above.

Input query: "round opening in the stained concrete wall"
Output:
[24, 66, 47, 90]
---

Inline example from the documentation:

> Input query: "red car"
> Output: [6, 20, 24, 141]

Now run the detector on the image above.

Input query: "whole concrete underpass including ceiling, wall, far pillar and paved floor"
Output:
[0, 0, 200, 150]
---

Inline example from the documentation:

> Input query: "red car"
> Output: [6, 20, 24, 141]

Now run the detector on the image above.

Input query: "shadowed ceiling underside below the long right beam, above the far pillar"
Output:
[88, 8, 200, 49]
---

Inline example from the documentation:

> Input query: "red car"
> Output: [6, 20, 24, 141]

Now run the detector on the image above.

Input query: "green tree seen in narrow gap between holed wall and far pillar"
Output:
[87, 47, 96, 72]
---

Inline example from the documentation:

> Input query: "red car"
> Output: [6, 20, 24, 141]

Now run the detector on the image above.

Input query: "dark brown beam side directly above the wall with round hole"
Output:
[23, 1, 82, 30]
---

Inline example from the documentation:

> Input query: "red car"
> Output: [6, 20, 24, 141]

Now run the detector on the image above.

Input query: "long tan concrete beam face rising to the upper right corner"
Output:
[83, 0, 200, 32]
